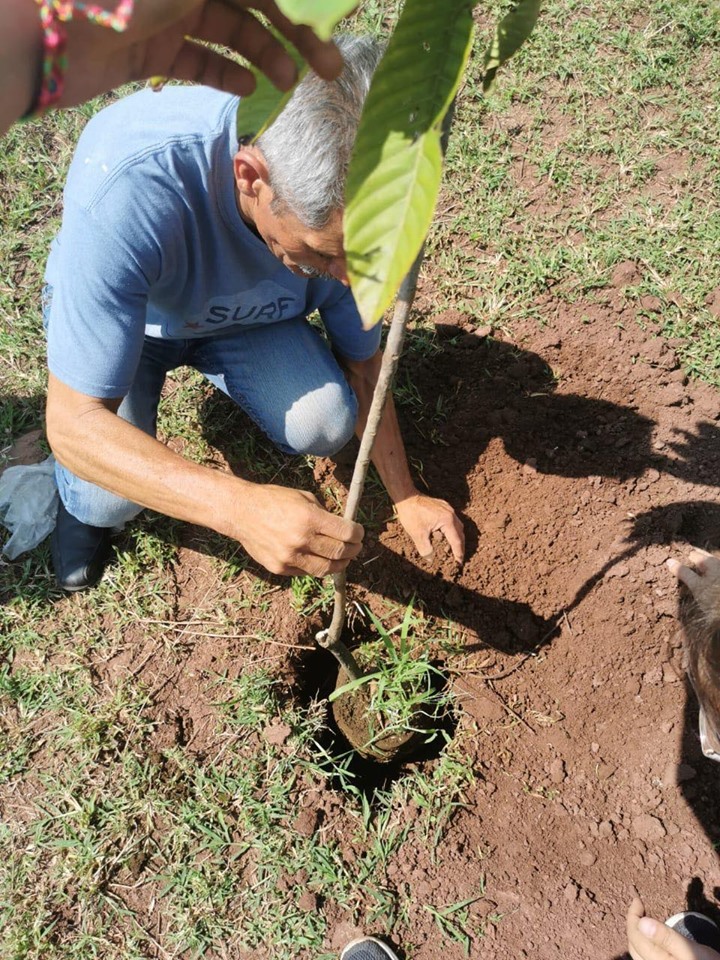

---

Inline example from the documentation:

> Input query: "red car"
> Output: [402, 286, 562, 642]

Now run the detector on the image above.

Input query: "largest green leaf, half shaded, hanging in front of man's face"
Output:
[345, 0, 473, 327]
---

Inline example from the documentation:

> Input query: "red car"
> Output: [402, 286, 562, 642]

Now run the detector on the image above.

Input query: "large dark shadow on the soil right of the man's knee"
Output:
[402, 327, 720, 486]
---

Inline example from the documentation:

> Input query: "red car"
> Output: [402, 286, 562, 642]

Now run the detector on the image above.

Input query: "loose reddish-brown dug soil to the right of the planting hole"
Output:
[139, 286, 720, 960]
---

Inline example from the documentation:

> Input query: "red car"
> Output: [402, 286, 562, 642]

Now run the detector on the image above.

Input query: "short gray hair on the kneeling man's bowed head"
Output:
[257, 35, 384, 230]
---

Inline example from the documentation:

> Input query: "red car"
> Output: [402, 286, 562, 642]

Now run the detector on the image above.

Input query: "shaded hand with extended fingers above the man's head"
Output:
[58, 0, 342, 107]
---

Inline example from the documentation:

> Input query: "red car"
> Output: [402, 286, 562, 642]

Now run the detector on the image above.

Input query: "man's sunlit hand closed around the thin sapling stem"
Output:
[236, 484, 364, 577]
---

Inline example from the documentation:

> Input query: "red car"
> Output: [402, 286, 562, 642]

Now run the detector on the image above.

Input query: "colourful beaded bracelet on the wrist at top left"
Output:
[23, 0, 135, 119]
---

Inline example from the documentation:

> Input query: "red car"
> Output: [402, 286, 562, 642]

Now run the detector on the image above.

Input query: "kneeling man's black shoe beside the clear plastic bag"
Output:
[52, 501, 110, 592]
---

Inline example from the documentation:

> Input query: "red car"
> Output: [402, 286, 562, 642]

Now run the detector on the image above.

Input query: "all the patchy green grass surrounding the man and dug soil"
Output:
[0, 0, 720, 960]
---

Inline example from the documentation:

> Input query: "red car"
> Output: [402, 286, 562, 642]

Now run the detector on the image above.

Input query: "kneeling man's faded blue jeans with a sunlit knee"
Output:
[49, 318, 357, 527]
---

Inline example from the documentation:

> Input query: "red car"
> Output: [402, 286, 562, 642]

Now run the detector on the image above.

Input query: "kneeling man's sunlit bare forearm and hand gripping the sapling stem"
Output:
[47, 374, 363, 577]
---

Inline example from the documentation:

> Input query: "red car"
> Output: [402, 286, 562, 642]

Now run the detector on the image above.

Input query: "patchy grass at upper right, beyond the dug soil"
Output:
[429, 2, 720, 384]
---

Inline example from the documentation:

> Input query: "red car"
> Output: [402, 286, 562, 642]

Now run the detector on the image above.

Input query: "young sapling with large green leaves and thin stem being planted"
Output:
[237, 0, 541, 720]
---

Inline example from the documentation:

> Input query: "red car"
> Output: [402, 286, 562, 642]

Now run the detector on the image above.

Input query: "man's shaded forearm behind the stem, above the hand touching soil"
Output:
[345, 352, 417, 503]
